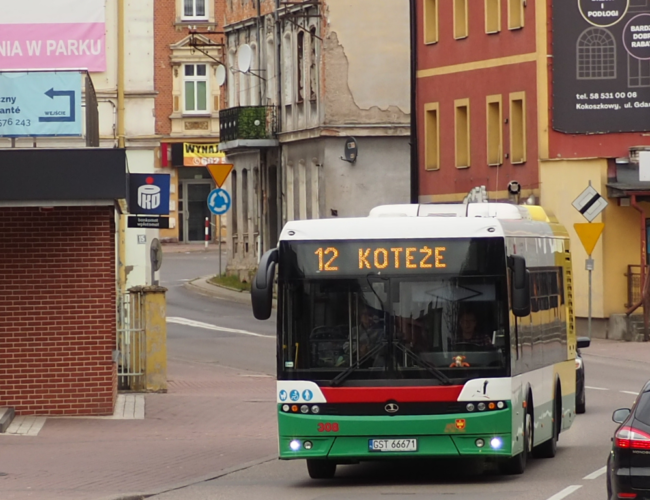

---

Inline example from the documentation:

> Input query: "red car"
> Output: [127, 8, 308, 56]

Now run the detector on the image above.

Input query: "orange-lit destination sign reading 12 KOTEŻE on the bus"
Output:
[284, 238, 505, 277]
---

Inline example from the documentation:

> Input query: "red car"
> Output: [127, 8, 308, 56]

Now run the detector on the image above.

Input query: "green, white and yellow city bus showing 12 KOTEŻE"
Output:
[251, 203, 577, 479]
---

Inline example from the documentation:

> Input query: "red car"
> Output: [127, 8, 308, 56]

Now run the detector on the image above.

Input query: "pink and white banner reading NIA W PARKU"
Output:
[0, 0, 106, 72]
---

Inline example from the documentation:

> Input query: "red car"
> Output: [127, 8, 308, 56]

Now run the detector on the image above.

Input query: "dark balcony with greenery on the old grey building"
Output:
[219, 106, 278, 151]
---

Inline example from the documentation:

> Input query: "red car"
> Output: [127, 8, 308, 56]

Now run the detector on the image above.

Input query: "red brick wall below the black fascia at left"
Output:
[0, 207, 117, 415]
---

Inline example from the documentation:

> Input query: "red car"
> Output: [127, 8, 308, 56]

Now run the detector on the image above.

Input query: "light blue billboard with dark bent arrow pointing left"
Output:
[0, 71, 83, 137]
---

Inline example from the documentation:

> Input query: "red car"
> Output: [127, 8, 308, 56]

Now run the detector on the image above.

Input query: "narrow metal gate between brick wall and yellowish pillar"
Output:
[116, 292, 145, 391]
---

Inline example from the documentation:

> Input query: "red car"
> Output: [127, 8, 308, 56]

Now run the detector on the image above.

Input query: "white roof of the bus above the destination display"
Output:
[280, 203, 568, 241]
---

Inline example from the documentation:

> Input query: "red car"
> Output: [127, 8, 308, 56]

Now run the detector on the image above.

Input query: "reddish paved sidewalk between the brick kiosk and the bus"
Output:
[0, 360, 277, 500]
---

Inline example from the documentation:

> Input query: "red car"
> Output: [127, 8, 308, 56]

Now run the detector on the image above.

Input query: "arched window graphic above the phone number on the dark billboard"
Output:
[576, 28, 616, 80]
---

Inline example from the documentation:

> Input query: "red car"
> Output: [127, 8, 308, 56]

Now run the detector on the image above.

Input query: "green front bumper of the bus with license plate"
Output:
[278, 410, 516, 461]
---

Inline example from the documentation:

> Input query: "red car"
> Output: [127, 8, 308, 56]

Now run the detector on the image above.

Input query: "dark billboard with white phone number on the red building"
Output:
[553, 0, 650, 134]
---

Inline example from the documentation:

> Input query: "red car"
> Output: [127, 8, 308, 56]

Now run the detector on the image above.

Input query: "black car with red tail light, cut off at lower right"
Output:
[607, 381, 650, 500]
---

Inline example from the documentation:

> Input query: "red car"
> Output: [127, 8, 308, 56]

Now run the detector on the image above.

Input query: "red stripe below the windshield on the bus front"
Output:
[320, 385, 463, 403]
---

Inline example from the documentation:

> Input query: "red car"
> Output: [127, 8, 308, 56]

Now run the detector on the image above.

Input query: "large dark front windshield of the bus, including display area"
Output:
[278, 238, 509, 386]
